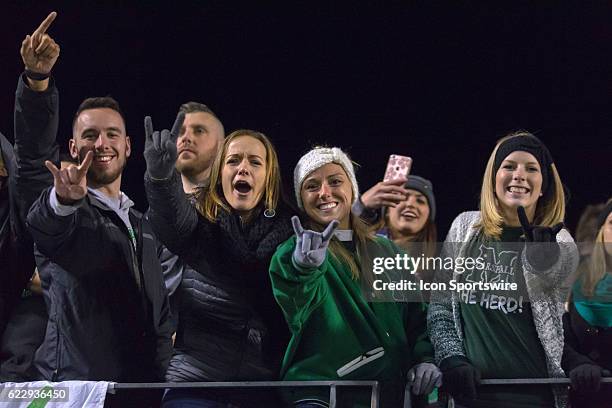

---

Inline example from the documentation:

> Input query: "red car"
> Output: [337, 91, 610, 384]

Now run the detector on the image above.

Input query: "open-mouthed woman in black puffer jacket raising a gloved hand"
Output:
[144, 112, 291, 407]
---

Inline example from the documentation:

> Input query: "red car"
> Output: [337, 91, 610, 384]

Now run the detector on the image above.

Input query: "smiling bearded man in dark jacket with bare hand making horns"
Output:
[27, 87, 171, 382]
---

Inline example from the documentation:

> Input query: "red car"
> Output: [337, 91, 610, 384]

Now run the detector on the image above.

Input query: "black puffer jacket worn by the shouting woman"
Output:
[145, 174, 293, 381]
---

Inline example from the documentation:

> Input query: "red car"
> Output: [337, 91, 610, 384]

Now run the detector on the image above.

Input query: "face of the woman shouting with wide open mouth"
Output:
[221, 136, 267, 216]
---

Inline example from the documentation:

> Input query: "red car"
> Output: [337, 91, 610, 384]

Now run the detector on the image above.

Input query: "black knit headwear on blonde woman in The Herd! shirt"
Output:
[493, 133, 553, 196]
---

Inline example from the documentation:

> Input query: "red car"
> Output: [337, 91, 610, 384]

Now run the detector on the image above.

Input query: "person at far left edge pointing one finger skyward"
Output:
[0, 13, 60, 382]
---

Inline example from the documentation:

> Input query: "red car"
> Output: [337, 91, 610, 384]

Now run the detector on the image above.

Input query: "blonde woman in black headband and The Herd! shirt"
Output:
[428, 131, 578, 408]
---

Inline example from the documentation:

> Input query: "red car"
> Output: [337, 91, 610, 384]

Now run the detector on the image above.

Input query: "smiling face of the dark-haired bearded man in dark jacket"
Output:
[69, 108, 131, 190]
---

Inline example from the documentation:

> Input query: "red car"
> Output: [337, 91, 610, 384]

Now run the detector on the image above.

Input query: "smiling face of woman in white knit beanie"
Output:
[300, 163, 353, 229]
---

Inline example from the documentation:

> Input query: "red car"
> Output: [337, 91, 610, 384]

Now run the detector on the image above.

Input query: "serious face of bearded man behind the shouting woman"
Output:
[176, 112, 223, 181]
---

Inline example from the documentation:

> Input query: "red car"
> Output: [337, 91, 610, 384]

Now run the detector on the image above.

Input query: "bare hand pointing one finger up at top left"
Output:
[20, 11, 60, 74]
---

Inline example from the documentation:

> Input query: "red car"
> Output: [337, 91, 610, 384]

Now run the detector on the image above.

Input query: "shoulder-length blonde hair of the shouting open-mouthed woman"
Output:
[196, 129, 281, 222]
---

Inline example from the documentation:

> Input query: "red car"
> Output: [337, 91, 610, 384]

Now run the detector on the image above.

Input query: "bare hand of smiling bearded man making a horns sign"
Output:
[45, 150, 93, 205]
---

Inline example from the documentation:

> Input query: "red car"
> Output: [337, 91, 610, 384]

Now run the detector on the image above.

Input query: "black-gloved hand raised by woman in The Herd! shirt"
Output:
[517, 206, 563, 271]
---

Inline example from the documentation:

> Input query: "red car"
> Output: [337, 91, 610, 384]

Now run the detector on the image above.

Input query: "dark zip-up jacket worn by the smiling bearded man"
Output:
[28, 189, 172, 382]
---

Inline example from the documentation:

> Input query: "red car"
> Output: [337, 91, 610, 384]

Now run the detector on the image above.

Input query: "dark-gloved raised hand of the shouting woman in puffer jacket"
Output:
[144, 112, 185, 180]
